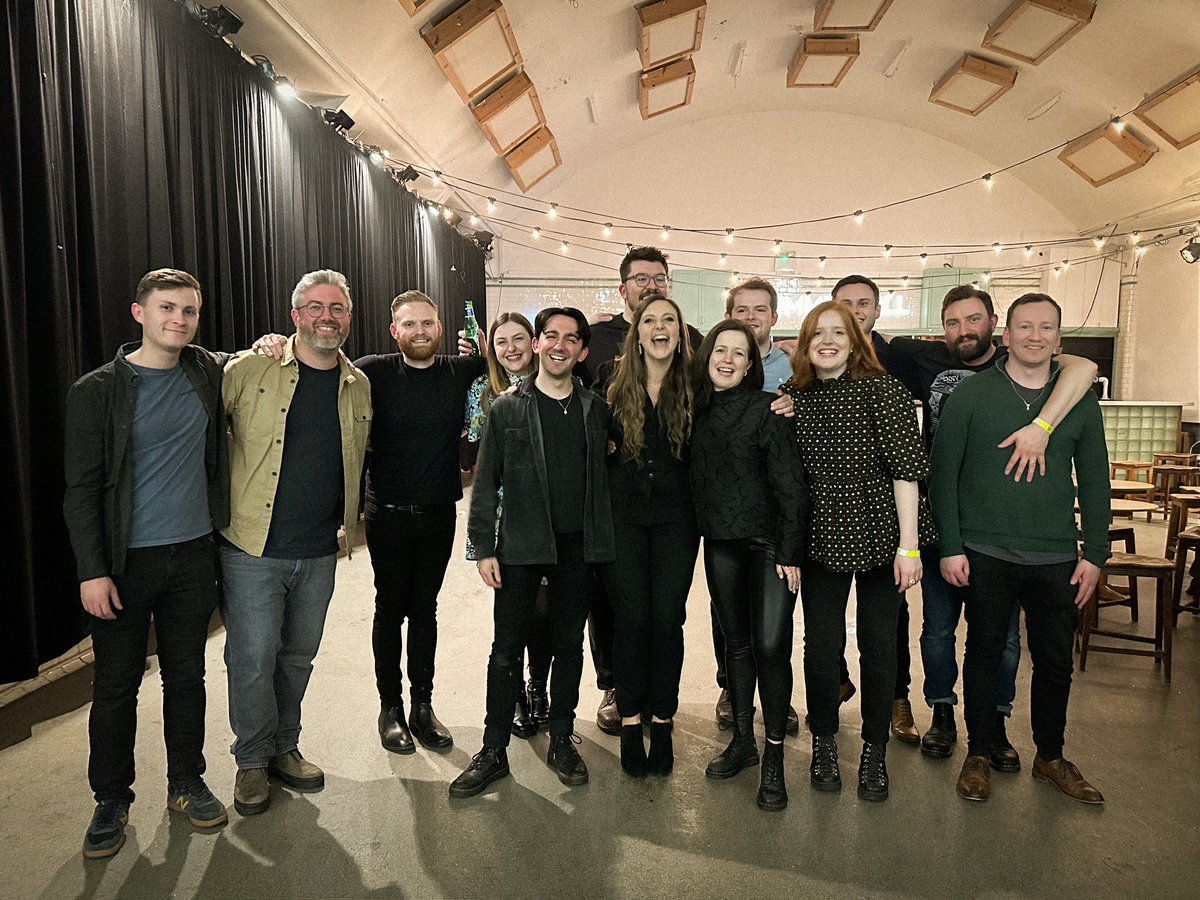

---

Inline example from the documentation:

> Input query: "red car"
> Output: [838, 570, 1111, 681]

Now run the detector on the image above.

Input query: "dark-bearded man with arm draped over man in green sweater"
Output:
[883, 284, 1097, 772]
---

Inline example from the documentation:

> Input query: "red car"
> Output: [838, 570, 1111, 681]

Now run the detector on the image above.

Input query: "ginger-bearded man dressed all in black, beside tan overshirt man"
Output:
[355, 290, 486, 754]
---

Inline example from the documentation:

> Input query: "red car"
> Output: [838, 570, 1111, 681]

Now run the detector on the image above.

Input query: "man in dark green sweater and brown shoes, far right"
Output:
[930, 294, 1110, 803]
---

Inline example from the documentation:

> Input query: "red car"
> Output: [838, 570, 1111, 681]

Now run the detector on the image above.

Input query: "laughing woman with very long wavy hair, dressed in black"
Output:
[605, 293, 700, 778]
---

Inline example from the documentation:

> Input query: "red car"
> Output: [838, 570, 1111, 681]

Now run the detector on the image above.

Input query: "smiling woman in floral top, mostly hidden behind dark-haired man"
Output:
[466, 312, 551, 738]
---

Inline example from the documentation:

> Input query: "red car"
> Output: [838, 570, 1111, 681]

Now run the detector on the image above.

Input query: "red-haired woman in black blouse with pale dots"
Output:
[787, 301, 934, 800]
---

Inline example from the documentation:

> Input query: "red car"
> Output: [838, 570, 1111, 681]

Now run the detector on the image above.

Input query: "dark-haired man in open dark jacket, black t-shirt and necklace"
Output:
[450, 307, 616, 798]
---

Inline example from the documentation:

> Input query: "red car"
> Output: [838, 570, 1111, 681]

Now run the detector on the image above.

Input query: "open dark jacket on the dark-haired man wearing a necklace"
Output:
[467, 378, 617, 565]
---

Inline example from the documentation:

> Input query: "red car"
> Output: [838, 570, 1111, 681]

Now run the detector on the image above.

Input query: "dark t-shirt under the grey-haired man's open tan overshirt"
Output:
[263, 360, 343, 559]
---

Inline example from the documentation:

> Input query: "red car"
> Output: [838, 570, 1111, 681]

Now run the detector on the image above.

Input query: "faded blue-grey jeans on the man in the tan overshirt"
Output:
[221, 544, 337, 769]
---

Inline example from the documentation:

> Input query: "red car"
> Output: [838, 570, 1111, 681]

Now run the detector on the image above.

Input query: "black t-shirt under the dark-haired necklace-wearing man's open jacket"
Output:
[533, 388, 588, 534]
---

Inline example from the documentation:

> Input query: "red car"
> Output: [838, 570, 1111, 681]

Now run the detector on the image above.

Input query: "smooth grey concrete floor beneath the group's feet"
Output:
[0, 505, 1200, 898]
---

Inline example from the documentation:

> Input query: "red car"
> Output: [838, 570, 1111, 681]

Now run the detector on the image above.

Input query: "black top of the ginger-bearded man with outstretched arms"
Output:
[354, 353, 487, 506]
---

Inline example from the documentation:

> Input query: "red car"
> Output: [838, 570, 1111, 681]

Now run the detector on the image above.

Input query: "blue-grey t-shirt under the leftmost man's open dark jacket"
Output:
[130, 362, 212, 547]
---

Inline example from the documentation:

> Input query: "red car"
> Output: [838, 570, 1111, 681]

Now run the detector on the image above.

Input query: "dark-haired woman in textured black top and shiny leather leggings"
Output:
[691, 319, 808, 810]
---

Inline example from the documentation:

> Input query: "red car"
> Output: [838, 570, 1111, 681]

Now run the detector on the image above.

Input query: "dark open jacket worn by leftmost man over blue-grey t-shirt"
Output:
[62, 341, 229, 582]
